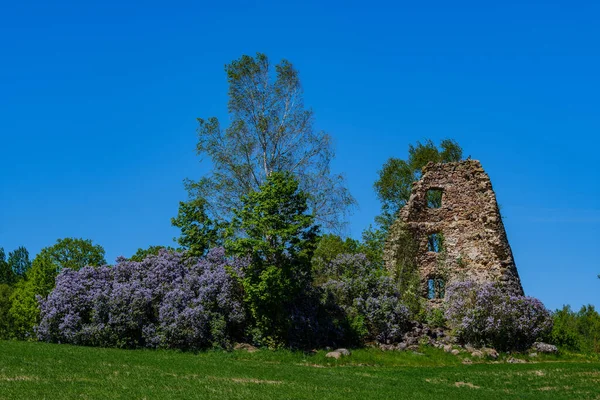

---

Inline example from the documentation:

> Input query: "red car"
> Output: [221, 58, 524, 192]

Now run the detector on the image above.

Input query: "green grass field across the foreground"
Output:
[0, 341, 600, 400]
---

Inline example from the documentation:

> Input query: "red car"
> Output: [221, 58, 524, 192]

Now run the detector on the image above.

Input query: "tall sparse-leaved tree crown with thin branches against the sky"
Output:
[186, 53, 355, 229]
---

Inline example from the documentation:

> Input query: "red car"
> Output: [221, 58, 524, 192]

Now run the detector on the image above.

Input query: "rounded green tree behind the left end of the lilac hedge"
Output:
[9, 238, 106, 339]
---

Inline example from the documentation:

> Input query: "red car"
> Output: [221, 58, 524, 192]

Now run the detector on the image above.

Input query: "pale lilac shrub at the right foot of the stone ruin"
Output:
[445, 281, 552, 351]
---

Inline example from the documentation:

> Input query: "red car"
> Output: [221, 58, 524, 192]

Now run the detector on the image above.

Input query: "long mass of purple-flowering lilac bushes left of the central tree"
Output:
[37, 248, 248, 350]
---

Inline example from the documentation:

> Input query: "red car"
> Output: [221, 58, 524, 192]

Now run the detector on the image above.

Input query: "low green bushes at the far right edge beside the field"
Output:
[551, 305, 600, 353]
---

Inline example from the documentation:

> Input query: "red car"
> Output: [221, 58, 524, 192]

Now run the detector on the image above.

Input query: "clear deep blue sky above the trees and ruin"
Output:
[0, 0, 600, 308]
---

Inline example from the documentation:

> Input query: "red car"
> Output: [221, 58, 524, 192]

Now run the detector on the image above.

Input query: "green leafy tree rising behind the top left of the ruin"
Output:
[374, 139, 463, 231]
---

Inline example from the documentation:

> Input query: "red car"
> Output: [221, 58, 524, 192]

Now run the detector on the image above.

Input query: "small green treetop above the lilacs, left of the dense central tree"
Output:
[171, 197, 223, 257]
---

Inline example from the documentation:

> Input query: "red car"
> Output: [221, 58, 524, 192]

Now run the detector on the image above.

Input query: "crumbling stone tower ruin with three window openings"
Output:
[384, 160, 523, 303]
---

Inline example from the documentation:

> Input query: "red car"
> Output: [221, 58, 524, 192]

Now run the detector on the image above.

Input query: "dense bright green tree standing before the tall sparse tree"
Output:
[226, 173, 319, 346]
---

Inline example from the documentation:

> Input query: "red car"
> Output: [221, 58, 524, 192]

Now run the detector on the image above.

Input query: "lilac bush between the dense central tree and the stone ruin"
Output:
[322, 254, 410, 343]
